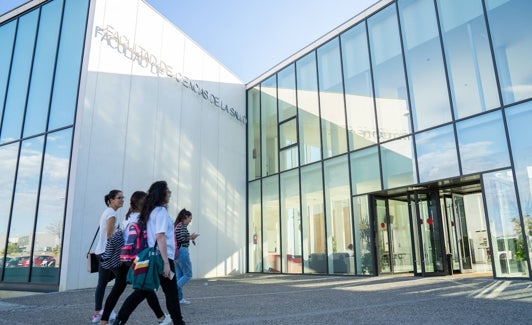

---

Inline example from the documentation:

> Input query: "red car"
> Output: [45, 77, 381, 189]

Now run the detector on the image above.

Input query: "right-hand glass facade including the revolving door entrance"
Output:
[247, 0, 532, 278]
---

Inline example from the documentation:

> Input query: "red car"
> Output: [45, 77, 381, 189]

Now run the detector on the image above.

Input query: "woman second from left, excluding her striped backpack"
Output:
[100, 191, 171, 325]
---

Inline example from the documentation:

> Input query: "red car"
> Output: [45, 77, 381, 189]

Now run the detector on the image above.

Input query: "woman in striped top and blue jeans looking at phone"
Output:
[174, 209, 199, 305]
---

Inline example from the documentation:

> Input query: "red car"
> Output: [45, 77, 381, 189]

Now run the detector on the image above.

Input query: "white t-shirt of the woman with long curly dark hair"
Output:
[147, 206, 175, 259]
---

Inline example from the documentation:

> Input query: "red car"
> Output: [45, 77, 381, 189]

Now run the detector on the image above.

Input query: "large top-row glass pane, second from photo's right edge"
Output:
[437, 0, 500, 119]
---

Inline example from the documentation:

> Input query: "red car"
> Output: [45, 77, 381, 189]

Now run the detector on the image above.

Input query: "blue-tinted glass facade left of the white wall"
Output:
[0, 0, 89, 287]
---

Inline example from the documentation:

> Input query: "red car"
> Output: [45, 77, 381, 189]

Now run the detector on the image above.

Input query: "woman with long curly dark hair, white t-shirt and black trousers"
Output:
[113, 181, 185, 325]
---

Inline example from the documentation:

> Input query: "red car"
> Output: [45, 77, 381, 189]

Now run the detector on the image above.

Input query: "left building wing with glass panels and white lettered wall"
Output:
[0, 0, 246, 291]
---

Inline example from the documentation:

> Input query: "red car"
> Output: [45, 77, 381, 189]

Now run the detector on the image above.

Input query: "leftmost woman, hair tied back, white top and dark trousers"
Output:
[92, 190, 124, 323]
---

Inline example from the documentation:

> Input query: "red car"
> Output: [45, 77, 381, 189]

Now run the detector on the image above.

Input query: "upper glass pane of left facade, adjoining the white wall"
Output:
[48, 0, 89, 130]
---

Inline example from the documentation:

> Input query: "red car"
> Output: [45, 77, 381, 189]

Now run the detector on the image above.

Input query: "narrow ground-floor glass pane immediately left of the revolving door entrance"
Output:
[353, 195, 375, 275]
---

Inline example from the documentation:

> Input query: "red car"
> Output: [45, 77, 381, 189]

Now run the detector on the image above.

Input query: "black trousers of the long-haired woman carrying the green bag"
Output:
[116, 260, 185, 325]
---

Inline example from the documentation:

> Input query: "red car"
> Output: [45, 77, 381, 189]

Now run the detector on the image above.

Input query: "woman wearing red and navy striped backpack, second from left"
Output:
[100, 191, 172, 325]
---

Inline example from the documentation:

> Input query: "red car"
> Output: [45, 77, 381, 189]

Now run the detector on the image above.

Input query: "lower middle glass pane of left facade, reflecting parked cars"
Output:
[4, 136, 44, 282]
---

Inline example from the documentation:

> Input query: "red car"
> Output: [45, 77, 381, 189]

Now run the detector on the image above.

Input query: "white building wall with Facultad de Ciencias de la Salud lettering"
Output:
[60, 0, 246, 290]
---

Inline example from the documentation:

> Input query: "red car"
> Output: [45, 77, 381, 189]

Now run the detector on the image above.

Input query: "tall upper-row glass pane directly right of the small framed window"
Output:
[296, 52, 321, 165]
